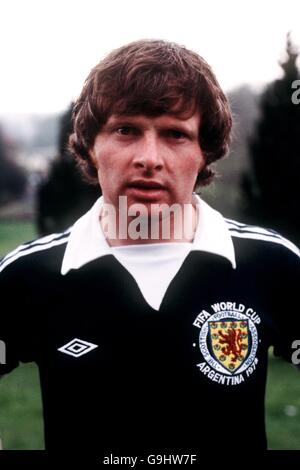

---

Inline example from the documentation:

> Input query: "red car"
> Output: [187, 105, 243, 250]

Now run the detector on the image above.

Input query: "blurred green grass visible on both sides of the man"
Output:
[0, 222, 300, 450]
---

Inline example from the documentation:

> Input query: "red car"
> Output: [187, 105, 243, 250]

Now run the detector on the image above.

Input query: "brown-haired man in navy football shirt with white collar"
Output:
[1, 40, 300, 455]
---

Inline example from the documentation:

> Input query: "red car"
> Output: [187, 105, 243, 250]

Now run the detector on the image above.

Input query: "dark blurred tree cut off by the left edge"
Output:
[0, 128, 27, 205]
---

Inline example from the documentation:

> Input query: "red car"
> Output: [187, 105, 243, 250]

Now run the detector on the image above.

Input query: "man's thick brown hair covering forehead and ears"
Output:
[69, 40, 232, 186]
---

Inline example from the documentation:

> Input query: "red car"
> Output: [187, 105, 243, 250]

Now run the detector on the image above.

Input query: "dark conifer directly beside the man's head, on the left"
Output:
[37, 104, 101, 235]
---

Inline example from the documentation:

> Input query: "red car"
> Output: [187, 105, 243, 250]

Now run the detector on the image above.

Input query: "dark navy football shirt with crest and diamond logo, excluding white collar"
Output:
[0, 217, 300, 455]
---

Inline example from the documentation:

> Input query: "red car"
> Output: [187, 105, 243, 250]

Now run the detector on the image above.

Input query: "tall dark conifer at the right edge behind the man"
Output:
[242, 34, 300, 242]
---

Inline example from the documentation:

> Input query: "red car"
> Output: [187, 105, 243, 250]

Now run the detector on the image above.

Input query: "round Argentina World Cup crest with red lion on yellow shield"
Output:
[194, 302, 260, 385]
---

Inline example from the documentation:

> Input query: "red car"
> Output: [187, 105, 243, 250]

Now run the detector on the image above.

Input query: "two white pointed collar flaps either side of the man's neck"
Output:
[61, 195, 236, 275]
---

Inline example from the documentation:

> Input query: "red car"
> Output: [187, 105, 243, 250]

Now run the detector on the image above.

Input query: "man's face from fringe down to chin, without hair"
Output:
[91, 113, 204, 212]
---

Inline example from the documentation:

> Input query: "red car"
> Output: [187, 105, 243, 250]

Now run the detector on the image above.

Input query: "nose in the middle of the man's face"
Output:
[134, 135, 163, 170]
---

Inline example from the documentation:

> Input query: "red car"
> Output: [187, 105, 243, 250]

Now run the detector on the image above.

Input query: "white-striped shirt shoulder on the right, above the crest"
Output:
[224, 218, 300, 258]
